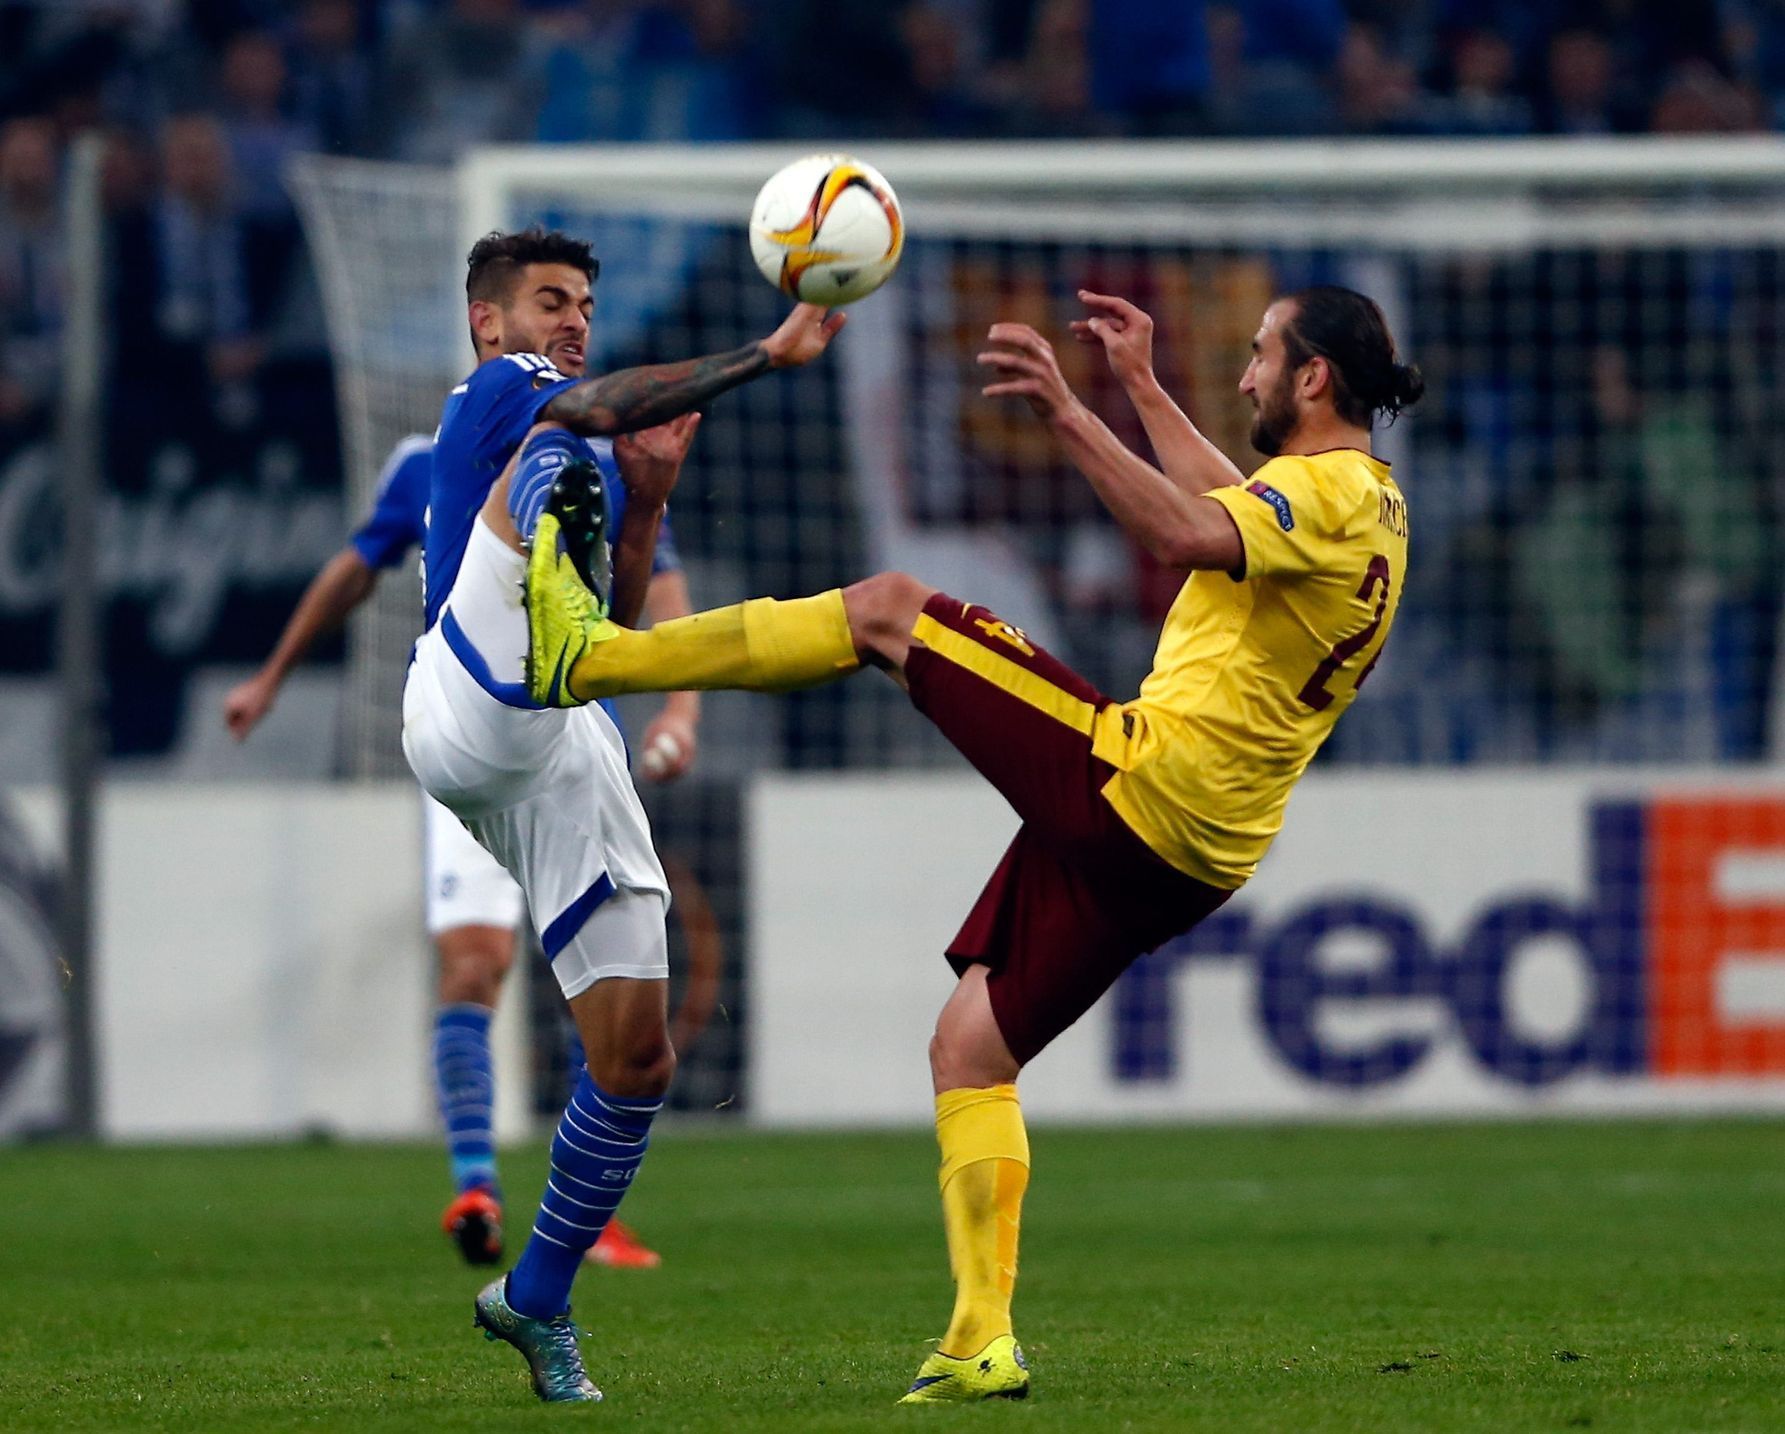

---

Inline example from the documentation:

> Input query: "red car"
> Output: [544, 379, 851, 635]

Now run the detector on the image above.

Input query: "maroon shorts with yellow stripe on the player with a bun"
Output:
[905, 593, 1232, 1064]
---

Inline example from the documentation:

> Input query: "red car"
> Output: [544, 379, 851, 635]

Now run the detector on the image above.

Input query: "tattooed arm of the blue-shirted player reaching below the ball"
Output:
[539, 304, 844, 436]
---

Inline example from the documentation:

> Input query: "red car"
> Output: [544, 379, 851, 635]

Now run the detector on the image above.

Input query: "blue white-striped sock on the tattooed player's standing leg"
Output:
[509, 1071, 664, 1320]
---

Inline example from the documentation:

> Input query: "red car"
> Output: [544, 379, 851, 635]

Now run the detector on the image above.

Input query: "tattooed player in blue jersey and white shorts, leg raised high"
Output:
[403, 229, 843, 1402]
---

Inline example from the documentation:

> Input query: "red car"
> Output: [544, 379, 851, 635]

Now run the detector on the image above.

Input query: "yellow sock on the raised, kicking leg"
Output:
[569, 588, 860, 702]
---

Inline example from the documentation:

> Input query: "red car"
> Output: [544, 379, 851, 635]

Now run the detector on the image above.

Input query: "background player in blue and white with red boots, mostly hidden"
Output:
[223, 434, 700, 1270]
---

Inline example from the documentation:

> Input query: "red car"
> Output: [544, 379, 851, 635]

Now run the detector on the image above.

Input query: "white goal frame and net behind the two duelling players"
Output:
[298, 141, 1785, 773]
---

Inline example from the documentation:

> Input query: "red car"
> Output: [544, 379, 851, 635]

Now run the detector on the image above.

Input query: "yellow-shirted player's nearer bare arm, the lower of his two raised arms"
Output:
[978, 323, 1246, 571]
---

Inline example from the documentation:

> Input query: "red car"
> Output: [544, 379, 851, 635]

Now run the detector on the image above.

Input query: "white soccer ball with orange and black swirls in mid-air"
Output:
[750, 154, 905, 305]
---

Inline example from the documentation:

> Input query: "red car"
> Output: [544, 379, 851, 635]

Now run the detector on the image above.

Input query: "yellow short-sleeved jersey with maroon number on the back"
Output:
[1092, 448, 1407, 889]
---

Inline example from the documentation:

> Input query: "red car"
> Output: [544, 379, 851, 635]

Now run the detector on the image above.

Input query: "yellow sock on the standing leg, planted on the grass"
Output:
[935, 1086, 1028, 1359]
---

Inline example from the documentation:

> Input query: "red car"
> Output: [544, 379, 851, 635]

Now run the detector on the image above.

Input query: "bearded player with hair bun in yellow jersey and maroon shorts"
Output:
[527, 288, 1424, 1404]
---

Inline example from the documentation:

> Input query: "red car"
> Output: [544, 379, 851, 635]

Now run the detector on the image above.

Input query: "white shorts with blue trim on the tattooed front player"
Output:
[403, 518, 669, 996]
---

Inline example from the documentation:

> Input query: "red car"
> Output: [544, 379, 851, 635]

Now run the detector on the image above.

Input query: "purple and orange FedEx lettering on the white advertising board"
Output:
[1110, 796, 1785, 1088]
